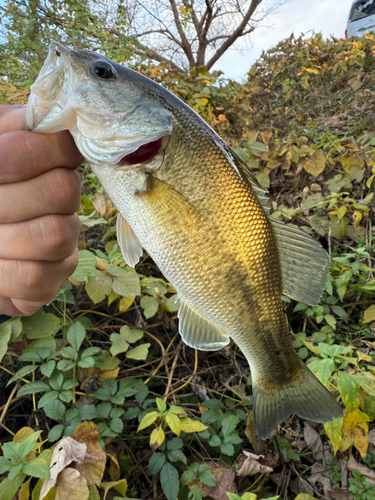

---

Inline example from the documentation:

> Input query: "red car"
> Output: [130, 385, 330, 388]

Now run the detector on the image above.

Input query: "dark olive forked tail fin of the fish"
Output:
[253, 364, 343, 439]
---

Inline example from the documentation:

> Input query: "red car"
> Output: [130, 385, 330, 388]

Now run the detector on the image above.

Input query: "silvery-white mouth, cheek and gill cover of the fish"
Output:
[25, 42, 173, 165]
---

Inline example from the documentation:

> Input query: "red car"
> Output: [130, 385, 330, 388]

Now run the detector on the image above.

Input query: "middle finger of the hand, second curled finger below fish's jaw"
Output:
[0, 168, 81, 224]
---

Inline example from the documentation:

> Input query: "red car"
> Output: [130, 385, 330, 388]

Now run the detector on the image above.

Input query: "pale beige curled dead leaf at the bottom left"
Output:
[39, 437, 86, 500]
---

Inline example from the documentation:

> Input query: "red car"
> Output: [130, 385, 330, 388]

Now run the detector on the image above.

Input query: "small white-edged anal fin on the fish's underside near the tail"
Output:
[178, 299, 229, 351]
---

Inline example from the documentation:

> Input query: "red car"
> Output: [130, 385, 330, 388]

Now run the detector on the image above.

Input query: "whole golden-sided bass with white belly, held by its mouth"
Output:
[25, 42, 343, 439]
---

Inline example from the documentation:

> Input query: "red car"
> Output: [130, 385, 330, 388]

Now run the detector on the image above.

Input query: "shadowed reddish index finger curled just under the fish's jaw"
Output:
[0, 130, 84, 184]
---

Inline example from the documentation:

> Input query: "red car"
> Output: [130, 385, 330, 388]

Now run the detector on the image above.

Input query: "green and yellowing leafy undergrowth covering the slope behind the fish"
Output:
[0, 25, 375, 500]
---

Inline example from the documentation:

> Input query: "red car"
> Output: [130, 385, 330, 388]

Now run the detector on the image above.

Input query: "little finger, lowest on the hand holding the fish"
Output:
[0, 249, 78, 307]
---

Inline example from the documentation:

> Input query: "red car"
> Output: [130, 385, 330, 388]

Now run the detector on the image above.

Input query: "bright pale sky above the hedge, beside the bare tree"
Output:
[212, 0, 353, 81]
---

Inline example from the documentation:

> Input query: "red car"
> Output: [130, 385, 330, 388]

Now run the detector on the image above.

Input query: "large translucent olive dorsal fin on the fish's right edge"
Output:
[269, 217, 329, 306]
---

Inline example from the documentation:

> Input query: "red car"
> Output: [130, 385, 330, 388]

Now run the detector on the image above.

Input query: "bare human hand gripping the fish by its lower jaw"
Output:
[0, 105, 83, 316]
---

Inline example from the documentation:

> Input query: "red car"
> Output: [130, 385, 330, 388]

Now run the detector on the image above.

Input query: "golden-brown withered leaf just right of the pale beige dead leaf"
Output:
[72, 421, 107, 486]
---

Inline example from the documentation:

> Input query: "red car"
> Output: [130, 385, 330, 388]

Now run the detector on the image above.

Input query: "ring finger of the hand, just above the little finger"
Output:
[0, 214, 81, 262]
